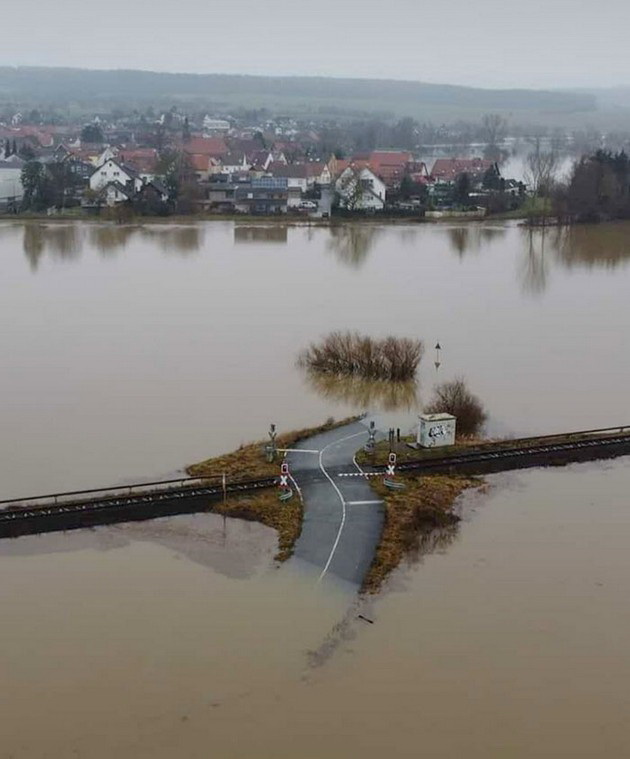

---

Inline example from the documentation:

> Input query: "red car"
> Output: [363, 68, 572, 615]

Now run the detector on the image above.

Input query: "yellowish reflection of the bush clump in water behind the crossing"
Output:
[305, 370, 420, 411]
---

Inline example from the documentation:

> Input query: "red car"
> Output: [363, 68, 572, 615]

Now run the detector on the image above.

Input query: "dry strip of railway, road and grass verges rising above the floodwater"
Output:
[0, 420, 630, 592]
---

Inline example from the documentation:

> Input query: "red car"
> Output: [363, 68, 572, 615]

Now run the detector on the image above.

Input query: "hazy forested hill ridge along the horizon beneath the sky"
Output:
[0, 67, 596, 118]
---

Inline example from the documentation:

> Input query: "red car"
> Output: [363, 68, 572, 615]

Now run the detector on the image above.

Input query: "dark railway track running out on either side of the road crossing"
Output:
[0, 426, 630, 538]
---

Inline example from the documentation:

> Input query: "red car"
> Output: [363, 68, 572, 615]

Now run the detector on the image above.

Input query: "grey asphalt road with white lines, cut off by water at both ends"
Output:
[287, 421, 384, 585]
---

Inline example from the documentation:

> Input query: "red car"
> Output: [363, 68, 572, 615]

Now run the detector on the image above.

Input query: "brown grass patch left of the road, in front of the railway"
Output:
[211, 488, 303, 561]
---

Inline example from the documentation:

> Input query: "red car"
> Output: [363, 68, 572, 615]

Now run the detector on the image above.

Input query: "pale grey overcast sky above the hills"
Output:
[0, 0, 630, 88]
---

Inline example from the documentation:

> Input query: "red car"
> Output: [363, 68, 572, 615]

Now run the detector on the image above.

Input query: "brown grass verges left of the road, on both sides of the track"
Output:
[186, 417, 357, 561]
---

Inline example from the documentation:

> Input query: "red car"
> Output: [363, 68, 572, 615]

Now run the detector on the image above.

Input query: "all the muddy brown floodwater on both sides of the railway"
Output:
[0, 218, 630, 759]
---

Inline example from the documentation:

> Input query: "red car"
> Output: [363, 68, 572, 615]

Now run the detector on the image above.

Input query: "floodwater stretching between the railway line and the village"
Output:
[0, 223, 630, 498]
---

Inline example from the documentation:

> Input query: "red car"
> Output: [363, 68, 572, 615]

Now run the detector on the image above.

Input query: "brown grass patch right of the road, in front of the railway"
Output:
[362, 475, 483, 593]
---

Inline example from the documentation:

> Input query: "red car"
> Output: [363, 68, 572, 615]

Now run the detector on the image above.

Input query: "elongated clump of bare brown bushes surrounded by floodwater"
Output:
[298, 332, 424, 382]
